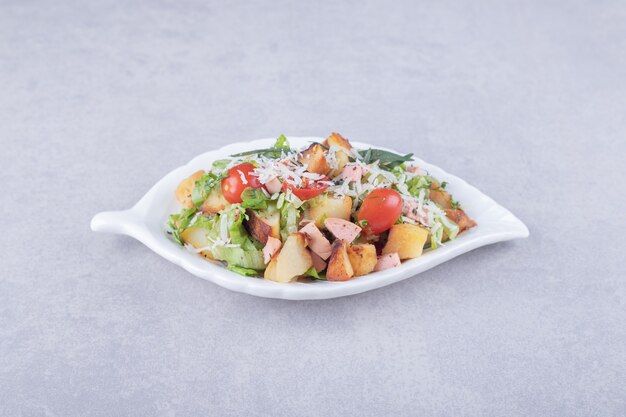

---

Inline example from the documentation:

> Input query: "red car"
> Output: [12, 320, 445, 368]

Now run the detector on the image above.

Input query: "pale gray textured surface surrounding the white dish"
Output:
[0, 0, 626, 416]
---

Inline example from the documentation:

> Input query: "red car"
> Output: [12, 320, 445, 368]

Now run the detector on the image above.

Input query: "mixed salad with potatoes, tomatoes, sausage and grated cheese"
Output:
[167, 133, 476, 282]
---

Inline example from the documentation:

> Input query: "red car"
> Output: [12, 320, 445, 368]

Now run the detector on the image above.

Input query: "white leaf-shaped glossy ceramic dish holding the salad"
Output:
[91, 137, 528, 300]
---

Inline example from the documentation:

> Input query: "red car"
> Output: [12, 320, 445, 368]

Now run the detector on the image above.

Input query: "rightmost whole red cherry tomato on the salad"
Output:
[357, 188, 402, 235]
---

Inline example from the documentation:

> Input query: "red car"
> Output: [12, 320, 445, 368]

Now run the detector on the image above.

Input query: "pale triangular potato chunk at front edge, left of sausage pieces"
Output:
[264, 233, 313, 282]
